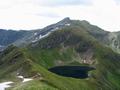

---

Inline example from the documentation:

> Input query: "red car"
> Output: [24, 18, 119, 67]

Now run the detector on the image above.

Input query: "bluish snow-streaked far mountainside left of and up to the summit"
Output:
[0, 18, 70, 46]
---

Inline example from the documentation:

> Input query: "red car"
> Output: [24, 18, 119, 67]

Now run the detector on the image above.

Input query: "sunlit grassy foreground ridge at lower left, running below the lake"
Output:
[0, 46, 95, 90]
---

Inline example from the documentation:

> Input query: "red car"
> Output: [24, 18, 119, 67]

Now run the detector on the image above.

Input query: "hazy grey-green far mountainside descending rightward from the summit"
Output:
[69, 21, 120, 53]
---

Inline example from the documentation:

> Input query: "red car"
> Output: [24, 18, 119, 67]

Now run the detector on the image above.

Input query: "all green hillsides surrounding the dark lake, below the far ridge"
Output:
[0, 26, 120, 90]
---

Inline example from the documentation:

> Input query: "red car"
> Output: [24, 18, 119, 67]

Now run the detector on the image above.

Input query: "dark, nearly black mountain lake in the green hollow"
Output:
[49, 66, 95, 79]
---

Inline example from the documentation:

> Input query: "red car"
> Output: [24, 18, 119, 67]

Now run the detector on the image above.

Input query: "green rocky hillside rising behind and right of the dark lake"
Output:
[25, 27, 120, 90]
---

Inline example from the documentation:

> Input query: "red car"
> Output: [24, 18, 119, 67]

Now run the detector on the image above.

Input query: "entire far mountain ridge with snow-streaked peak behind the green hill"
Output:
[0, 18, 120, 53]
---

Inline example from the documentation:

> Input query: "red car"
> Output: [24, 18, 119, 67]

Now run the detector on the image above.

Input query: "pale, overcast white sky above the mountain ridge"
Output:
[0, 0, 120, 31]
